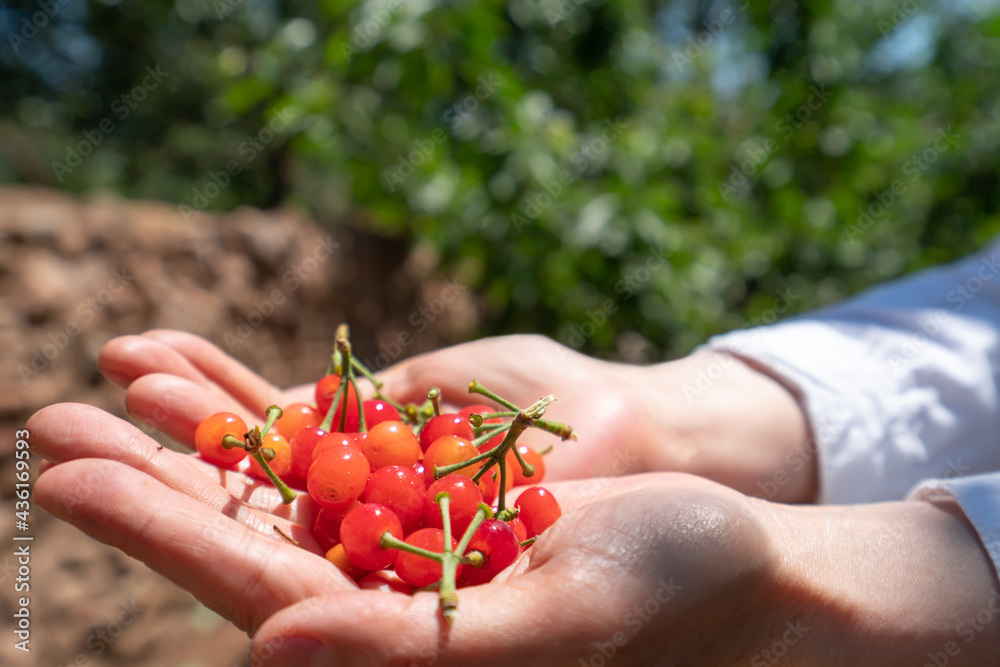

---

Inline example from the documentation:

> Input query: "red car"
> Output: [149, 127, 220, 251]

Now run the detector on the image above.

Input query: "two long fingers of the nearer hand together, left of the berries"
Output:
[27, 404, 356, 633]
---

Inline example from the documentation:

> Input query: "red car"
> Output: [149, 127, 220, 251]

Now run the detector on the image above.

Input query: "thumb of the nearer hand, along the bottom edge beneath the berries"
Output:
[249, 567, 608, 667]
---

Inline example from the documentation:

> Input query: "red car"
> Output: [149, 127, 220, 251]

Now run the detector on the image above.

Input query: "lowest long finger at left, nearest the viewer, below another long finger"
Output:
[35, 459, 351, 632]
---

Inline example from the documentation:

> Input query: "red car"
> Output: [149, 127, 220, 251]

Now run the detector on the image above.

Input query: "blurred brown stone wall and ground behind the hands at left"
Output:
[0, 188, 475, 667]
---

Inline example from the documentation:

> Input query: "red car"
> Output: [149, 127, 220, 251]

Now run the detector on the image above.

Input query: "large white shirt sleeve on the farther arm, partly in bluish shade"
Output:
[707, 237, 1000, 504]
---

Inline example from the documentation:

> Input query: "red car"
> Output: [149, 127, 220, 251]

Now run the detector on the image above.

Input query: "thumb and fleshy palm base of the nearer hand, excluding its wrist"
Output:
[250, 474, 770, 667]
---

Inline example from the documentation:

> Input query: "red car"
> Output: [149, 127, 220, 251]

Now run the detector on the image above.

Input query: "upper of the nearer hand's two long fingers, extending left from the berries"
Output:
[27, 403, 319, 532]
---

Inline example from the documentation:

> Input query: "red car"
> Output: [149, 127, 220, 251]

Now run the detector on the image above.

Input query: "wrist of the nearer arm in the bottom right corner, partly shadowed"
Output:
[752, 501, 1000, 667]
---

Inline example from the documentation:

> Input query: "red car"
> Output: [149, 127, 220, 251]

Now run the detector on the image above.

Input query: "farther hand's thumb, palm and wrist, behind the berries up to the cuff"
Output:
[381, 335, 817, 502]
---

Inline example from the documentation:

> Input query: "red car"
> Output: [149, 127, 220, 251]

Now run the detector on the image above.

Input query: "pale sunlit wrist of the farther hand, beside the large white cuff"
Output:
[639, 351, 818, 502]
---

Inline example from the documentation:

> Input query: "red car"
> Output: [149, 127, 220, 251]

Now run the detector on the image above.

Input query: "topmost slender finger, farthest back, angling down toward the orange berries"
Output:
[143, 329, 281, 415]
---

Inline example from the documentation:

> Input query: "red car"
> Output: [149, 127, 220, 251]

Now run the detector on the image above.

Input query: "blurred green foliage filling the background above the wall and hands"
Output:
[0, 0, 1000, 360]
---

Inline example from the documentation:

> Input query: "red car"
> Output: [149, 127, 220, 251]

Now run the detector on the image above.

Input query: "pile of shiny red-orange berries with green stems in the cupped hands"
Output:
[195, 325, 576, 621]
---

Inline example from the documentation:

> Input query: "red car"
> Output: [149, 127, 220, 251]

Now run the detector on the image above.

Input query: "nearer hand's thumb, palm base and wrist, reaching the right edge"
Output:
[250, 473, 1000, 667]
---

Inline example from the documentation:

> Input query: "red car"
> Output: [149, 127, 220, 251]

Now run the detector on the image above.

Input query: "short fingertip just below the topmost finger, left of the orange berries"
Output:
[97, 336, 210, 389]
